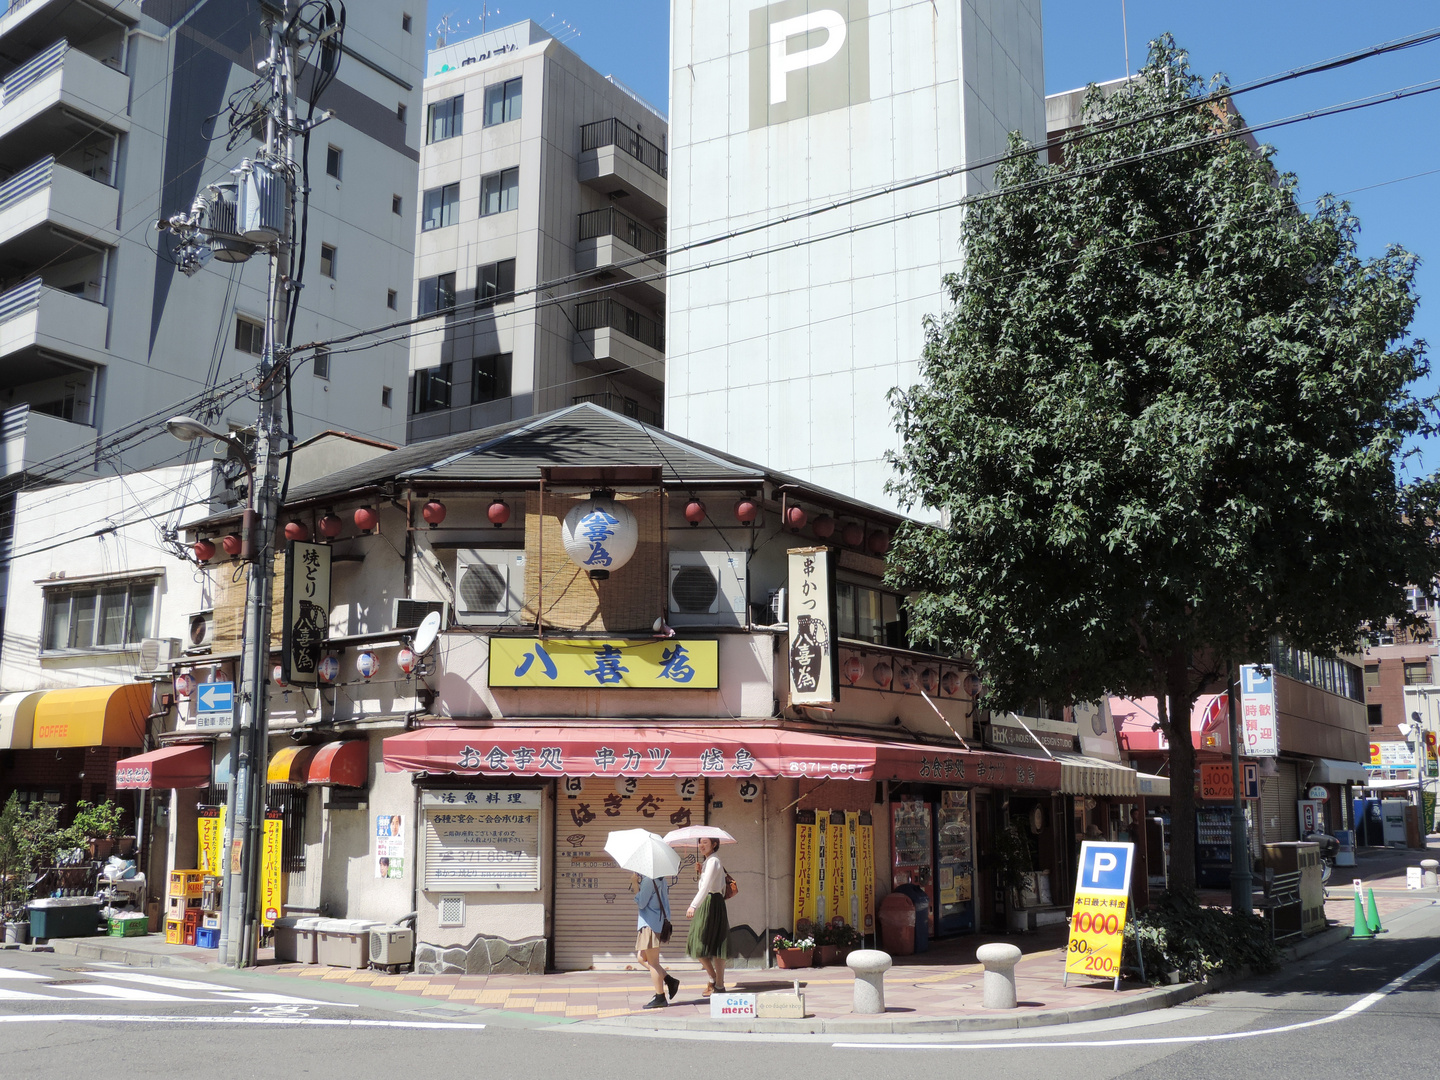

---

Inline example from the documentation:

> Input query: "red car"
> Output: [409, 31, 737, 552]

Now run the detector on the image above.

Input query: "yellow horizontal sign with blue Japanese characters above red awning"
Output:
[490, 636, 720, 690]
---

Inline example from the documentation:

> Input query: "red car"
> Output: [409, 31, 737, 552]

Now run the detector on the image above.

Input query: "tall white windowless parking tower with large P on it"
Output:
[665, 0, 1045, 505]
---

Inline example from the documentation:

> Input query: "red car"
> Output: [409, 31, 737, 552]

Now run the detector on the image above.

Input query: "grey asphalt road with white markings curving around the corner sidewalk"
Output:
[0, 904, 1440, 1080]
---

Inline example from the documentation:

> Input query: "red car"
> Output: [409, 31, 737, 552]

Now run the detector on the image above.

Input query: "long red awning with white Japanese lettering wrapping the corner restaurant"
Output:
[384, 724, 1060, 791]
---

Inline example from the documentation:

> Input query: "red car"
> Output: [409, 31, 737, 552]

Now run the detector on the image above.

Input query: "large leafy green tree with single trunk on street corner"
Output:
[890, 37, 1440, 886]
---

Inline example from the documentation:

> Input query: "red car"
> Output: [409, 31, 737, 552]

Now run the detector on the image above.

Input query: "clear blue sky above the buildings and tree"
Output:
[428, 0, 1440, 471]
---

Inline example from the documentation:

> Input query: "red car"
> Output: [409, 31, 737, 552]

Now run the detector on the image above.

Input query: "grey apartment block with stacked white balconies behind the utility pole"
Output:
[0, 0, 425, 477]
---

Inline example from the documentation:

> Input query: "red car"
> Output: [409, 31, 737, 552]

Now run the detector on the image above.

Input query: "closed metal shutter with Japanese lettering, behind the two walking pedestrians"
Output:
[552, 776, 702, 971]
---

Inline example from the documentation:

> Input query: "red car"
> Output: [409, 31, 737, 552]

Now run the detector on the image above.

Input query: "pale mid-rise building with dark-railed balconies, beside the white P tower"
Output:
[406, 22, 668, 442]
